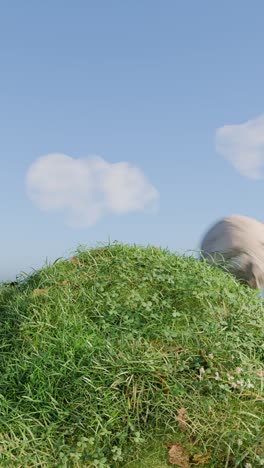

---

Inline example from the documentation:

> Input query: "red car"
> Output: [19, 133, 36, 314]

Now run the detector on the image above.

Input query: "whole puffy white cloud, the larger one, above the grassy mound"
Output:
[26, 154, 159, 228]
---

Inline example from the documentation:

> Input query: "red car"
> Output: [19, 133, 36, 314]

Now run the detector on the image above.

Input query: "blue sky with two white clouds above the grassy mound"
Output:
[0, 0, 264, 280]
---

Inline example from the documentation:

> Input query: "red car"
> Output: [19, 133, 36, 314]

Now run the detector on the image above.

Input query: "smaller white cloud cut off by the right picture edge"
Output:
[216, 115, 264, 179]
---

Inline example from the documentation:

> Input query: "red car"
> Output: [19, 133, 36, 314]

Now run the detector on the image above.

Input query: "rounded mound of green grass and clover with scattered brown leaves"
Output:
[0, 244, 264, 468]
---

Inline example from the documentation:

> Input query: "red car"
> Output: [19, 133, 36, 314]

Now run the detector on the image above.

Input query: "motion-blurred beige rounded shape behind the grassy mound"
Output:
[201, 215, 264, 289]
